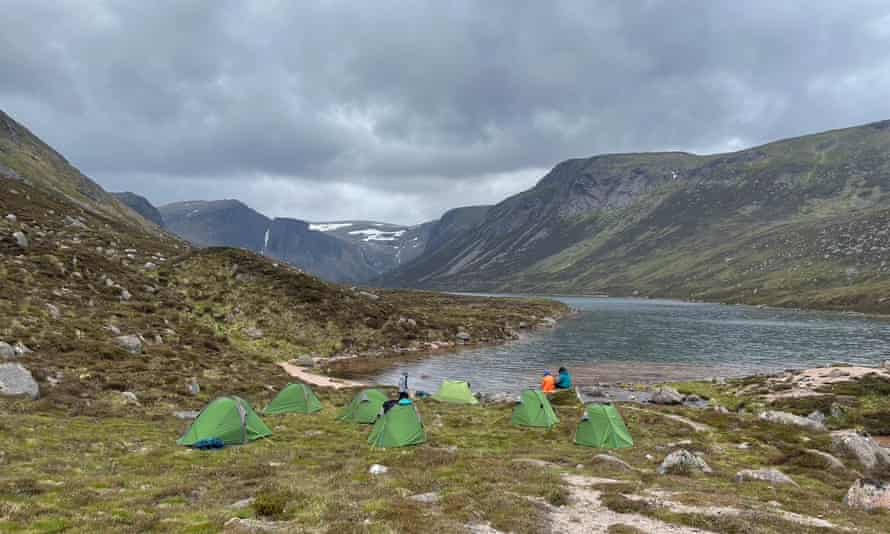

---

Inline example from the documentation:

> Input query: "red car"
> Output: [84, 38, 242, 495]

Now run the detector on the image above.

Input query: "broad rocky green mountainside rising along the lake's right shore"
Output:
[383, 121, 890, 311]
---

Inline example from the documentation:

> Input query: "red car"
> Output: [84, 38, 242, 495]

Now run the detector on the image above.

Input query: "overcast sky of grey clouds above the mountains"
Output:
[0, 0, 890, 223]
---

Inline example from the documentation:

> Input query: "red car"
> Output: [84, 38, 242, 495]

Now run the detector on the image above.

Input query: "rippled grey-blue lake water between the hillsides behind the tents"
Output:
[370, 297, 890, 392]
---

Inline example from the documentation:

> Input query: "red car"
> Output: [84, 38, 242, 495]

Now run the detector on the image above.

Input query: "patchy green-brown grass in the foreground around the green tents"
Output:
[0, 391, 890, 533]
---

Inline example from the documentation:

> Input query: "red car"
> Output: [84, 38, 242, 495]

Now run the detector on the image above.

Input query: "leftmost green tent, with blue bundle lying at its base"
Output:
[176, 397, 272, 447]
